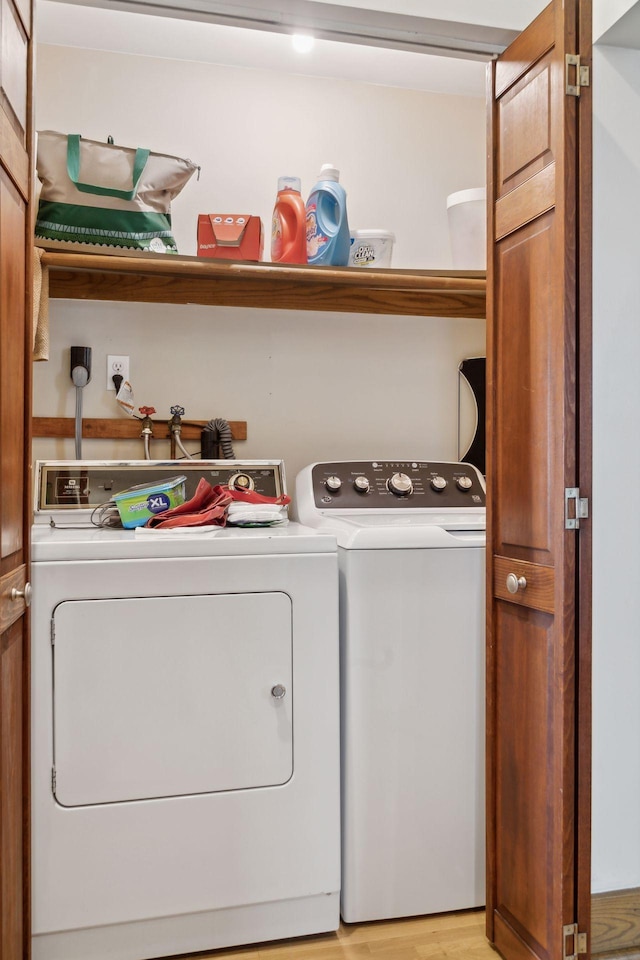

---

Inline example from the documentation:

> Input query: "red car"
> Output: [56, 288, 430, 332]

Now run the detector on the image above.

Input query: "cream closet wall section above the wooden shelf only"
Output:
[36, 45, 485, 268]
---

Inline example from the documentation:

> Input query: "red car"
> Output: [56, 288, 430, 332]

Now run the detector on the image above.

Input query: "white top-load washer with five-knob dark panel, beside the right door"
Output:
[296, 461, 485, 922]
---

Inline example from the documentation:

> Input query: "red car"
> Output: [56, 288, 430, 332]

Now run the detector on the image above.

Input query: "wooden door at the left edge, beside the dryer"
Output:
[0, 0, 32, 960]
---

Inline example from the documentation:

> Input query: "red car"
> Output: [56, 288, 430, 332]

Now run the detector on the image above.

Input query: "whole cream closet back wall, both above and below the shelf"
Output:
[34, 45, 485, 488]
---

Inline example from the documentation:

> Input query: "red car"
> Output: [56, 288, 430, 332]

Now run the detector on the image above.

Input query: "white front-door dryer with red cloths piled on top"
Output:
[32, 461, 340, 960]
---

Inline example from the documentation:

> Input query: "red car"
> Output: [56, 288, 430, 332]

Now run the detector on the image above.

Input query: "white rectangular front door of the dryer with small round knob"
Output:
[53, 593, 293, 806]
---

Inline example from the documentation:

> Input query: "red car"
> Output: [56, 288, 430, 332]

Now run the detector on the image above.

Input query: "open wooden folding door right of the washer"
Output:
[487, 0, 591, 960]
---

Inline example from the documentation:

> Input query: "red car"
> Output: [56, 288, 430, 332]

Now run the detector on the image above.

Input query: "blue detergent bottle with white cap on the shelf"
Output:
[307, 163, 351, 267]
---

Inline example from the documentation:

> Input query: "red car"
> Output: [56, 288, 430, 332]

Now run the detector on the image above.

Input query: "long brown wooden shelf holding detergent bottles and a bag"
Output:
[42, 244, 486, 319]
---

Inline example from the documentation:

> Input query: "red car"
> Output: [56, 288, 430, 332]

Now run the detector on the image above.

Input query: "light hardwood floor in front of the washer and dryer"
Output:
[174, 910, 499, 960]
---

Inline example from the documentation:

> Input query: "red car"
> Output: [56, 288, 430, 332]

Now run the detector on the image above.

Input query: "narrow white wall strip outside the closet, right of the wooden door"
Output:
[591, 39, 640, 892]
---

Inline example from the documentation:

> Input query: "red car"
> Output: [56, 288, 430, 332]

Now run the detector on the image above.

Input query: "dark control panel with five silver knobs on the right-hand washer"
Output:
[311, 460, 485, 512]
